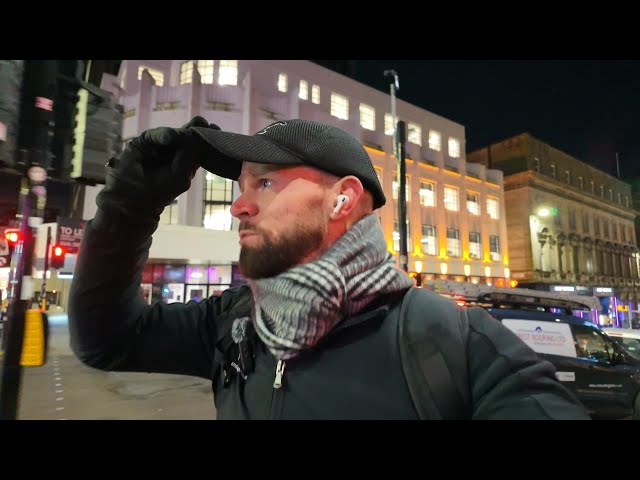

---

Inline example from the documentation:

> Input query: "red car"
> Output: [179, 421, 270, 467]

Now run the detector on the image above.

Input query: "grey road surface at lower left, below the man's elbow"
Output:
[12, 316, 216, 420]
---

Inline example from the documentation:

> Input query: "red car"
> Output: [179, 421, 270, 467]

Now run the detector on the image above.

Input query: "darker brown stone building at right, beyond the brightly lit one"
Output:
[467, 133, 640, 326]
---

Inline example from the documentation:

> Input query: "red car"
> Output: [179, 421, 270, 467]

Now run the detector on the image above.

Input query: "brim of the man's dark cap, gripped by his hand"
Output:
[191, 127, 305, 180]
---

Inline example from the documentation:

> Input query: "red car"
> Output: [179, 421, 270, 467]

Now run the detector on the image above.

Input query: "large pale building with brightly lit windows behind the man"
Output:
[1, 60, 509, 308]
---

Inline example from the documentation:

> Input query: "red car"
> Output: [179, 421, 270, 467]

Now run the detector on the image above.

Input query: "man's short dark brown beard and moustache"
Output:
[240, 221, 327, 279]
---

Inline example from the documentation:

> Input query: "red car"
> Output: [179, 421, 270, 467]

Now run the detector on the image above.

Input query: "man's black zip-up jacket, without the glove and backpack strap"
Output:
[69, 211, 587, 419]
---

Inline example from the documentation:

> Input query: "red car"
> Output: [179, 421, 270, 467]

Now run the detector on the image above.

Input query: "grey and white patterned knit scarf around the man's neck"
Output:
[232, 213, 413, 360]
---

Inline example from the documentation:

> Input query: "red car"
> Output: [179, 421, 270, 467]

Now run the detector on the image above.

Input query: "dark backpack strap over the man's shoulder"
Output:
[398, 287, 471, 420]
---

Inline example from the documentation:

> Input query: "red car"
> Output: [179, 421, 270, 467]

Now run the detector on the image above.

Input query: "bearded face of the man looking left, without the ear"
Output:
[231, 162, 331, 279]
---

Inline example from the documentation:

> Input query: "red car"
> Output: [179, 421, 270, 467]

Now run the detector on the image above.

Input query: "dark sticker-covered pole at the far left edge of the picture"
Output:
[0, 60, 58, 420]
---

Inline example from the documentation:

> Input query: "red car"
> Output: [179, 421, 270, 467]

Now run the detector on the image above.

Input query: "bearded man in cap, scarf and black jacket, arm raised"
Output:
[69, 117, 588, 419]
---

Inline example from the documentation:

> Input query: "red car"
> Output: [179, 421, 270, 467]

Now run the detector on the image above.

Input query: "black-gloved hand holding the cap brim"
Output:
[96, 117, 220, 222]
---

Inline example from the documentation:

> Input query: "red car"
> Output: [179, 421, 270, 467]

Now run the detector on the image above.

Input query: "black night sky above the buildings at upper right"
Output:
[353, 60, 640, 179]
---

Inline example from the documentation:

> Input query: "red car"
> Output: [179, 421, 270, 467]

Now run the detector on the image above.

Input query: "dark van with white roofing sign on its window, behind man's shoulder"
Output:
[486, 305, 640, 420]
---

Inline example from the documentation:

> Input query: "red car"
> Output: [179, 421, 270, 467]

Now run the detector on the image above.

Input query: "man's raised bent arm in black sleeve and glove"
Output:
[68, 117, 218, 378]
